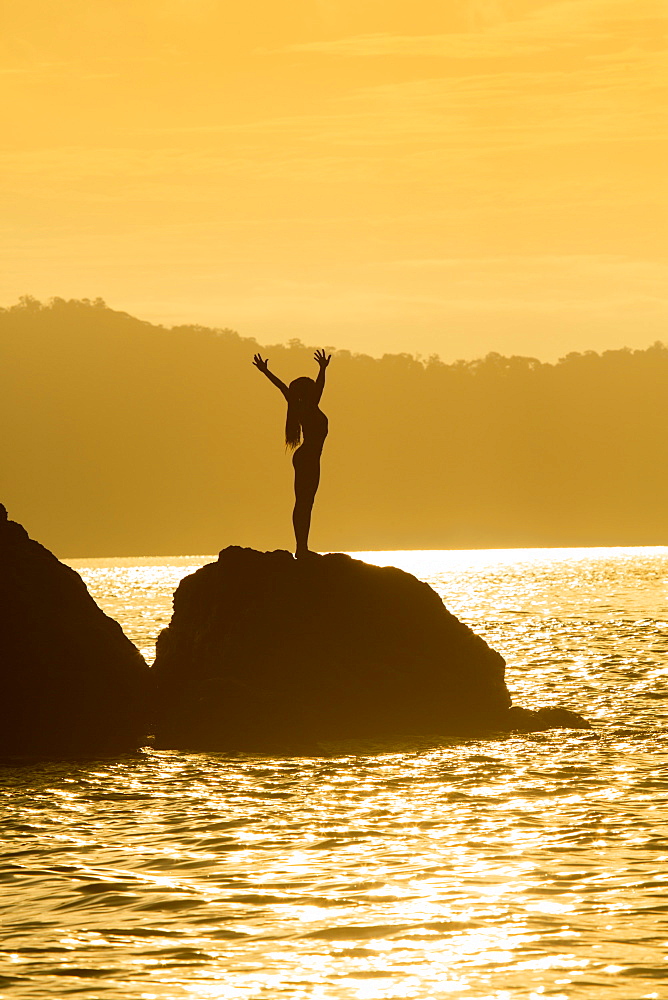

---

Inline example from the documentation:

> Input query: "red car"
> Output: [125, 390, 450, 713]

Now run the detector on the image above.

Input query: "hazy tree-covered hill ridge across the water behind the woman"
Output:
[0, 297, 668, 557]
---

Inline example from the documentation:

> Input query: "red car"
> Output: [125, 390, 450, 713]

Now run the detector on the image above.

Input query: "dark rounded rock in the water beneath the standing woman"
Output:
[153, 547, 586, 750]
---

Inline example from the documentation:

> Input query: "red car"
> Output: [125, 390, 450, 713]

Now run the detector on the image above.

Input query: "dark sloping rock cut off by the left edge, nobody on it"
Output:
[0, 504, 150, 754]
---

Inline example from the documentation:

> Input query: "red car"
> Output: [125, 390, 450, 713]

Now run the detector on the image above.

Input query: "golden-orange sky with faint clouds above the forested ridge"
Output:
[0, 0, 668, 360]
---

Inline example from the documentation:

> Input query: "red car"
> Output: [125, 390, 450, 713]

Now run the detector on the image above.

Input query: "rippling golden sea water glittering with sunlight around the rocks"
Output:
[0, 548, 668, 1000]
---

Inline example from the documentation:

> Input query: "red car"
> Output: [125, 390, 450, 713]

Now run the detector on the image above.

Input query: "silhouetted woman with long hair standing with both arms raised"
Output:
[253, 351, 332, 559]
